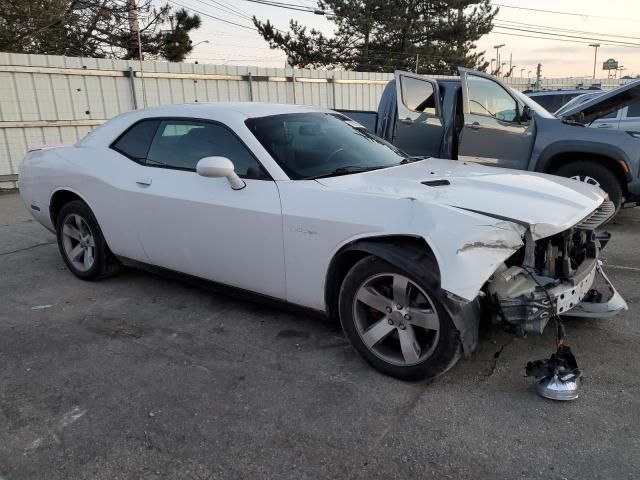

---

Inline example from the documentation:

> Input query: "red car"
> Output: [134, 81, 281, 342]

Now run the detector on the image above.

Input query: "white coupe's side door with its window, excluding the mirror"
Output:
[122, 119, 285, 298]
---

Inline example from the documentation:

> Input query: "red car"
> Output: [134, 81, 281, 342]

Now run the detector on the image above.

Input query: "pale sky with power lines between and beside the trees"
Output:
[180, 0, 640, 78]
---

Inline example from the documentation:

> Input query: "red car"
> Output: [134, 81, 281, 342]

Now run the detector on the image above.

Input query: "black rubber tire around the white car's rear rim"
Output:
[56, 200, 119, 280]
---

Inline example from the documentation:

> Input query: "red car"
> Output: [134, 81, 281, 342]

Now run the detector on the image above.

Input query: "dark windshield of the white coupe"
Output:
[246, 112, 409, 180]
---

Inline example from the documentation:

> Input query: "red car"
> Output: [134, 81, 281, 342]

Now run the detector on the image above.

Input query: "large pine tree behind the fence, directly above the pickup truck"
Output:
[253, 0, 498, 74]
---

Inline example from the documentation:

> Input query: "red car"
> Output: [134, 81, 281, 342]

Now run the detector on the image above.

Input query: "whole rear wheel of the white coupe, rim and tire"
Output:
[56, 200, 118, 280]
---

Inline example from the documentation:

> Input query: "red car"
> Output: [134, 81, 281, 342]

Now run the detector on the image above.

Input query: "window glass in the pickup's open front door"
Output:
[467, 75, 518, 122]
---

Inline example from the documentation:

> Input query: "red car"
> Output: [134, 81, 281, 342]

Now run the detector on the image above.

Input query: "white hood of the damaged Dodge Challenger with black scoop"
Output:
[317, 158, 606, 238]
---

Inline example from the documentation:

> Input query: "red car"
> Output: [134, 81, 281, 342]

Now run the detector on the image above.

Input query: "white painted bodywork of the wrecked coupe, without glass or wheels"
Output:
[20, 103, 605, 311]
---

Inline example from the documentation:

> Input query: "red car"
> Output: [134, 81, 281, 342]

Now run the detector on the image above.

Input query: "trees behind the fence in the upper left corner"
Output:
[0, 0, 200, 62]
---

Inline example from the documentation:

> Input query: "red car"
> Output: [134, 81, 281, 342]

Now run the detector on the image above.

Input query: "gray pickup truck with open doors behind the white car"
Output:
[343, 68, 640, 208]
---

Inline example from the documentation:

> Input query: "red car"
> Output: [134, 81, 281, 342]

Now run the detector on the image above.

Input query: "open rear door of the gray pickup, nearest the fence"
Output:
[393, 71, 444, 157]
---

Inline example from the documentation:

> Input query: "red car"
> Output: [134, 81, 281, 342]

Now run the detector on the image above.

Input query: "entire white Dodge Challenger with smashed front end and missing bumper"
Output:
[19, 103, 626, 379]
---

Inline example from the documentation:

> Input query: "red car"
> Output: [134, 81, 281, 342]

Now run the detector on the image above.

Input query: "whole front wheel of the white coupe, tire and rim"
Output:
[339, 256, 461, 380]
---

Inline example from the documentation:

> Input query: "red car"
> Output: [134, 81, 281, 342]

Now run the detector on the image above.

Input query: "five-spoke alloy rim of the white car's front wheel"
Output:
[353, 273, 440, 366]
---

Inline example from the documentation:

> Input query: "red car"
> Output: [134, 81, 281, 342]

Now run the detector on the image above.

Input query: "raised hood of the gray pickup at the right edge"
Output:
[560, 80, 640, 125]
